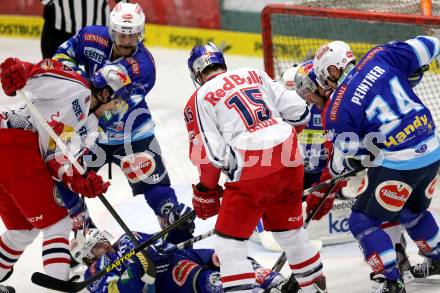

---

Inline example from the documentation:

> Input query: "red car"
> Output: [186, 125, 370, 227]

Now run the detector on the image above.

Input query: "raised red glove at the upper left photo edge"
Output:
[0, 58, 30, 96]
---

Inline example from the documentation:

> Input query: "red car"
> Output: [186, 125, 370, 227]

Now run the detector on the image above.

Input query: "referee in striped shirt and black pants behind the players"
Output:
[41, 0, 128, 58]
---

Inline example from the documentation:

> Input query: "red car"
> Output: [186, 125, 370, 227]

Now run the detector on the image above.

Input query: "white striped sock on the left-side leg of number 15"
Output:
[215, 236, 256, 293]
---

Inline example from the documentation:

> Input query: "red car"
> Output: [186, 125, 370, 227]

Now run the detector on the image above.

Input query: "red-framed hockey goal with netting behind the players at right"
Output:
[261, 0, 440, 133]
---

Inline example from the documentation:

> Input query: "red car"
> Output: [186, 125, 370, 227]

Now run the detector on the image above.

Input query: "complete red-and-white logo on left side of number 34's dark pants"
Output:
[375, 180, 412, 212]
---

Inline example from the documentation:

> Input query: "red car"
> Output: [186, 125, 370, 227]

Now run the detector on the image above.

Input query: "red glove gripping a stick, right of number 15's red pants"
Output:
[306, 180, 347, 220]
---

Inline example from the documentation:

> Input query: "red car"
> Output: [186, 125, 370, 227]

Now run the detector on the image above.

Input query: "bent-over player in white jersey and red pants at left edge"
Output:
[0, 58, 110, 288]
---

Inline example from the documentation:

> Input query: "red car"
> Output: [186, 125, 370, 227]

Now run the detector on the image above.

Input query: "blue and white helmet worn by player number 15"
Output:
[188, 42, 226, 86]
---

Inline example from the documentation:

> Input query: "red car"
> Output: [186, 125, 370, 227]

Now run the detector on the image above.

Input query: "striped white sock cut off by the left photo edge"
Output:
[0, 229, 39, 280]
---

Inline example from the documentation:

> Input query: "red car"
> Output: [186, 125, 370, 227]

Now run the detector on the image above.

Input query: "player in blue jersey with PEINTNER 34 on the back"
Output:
[313, 36, 440, 292]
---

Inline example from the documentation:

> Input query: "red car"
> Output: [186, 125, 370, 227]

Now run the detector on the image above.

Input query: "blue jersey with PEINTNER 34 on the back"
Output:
[325, 36, 440, 170]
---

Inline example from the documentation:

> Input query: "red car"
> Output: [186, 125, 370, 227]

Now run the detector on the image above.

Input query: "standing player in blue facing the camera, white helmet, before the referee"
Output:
[54, 3, 193, 242]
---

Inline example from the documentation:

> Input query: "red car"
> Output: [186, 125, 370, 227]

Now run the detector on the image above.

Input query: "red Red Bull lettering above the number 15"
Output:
[204, 70, 263, 106]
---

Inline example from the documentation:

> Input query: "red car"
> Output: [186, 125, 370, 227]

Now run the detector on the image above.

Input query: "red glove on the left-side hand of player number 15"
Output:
[193, 183, 223, 220]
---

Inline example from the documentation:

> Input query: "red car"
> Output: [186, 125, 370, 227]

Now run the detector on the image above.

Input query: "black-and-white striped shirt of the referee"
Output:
[41, 0, 127, 34]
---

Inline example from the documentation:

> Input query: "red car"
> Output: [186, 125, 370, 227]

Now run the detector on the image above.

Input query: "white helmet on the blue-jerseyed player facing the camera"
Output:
[109, 3, 145, 46]
